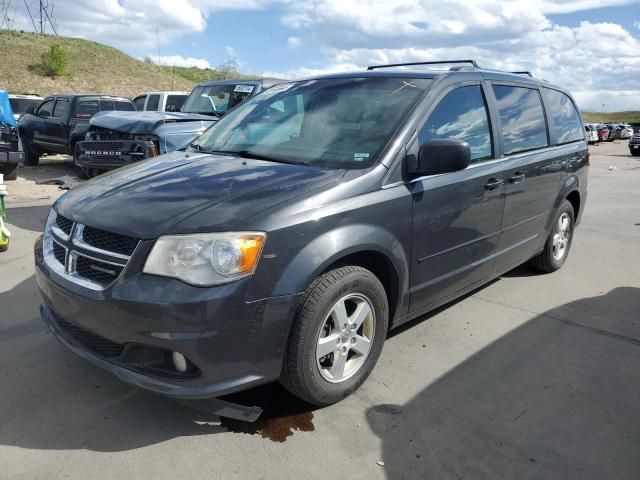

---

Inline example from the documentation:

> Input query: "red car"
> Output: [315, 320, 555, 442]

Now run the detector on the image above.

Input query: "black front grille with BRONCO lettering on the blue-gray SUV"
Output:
[75, 140, 157, 170]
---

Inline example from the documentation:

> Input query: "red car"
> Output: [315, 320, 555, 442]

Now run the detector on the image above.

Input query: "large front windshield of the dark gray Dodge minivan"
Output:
[194, 77, 431, 169]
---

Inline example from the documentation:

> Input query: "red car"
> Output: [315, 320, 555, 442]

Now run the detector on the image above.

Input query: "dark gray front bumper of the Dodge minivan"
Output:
[35, 239, 299, 399]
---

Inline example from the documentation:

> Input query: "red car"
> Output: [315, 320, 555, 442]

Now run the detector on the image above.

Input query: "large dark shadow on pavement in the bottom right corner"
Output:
[367, 287, 640, 480]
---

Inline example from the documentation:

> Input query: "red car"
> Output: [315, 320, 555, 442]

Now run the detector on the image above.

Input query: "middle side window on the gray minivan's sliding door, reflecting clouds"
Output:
[493, 85, 549, 155]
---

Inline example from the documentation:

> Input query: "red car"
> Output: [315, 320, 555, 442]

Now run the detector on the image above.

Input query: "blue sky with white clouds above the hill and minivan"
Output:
[7, 0, 640, 111]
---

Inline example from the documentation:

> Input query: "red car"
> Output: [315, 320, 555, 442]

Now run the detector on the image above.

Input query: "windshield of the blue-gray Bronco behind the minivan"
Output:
[180, 83, 256, 116]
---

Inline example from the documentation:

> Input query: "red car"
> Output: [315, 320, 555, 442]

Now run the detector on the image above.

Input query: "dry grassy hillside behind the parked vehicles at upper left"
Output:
[0, 30, 255, 98]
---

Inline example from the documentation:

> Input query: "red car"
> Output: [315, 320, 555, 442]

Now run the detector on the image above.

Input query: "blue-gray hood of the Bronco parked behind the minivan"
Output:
[89, 111, 218, 135]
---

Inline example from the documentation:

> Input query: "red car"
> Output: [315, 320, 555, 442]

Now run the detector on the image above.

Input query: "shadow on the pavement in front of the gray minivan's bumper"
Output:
[0, 275, 314, 452]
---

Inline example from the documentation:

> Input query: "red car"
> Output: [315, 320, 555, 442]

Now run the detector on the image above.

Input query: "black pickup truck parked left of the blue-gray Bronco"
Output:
[18, 94, 135, 165]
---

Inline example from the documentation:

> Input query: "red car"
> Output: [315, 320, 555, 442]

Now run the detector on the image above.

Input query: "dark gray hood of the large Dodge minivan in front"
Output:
[55, 152, 345, 239]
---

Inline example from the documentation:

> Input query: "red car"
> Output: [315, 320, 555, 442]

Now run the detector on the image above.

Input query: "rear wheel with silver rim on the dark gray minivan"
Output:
[531, 200, 575, 273]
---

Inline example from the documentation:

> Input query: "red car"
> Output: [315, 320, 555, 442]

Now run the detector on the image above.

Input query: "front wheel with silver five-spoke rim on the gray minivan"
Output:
[280, 266, 389, 406]
